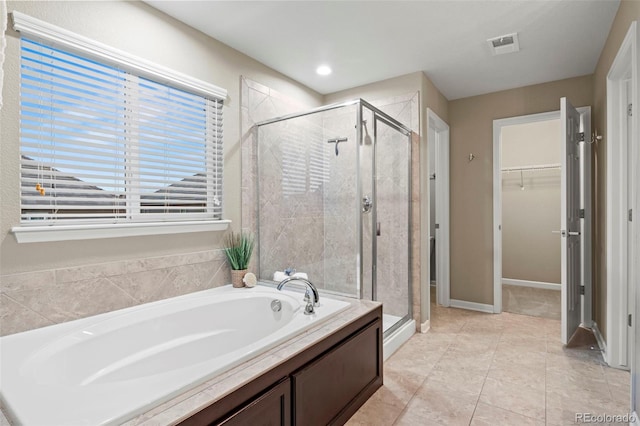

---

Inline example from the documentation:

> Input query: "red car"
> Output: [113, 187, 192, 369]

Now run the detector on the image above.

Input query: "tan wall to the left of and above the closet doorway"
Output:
[449, 76, 593, 305]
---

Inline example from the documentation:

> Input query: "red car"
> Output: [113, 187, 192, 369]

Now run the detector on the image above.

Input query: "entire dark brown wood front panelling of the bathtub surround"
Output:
[181, 307, 382, 426]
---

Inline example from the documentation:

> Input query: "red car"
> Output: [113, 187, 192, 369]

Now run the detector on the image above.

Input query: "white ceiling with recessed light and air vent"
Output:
[145, 0, 619, 100]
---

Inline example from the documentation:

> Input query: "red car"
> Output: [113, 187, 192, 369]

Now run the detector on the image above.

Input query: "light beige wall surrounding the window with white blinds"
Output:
[0, 1, 323, 274]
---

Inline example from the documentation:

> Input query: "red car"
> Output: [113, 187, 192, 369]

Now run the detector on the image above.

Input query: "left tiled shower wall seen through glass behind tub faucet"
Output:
[258, 115, 325, 288]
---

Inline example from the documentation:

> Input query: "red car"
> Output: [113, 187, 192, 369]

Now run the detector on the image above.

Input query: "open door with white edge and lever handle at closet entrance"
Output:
[560, 98, 582, 344]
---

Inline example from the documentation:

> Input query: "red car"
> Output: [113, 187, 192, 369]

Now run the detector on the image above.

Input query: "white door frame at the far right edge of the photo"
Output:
[604, 21, 640, 372]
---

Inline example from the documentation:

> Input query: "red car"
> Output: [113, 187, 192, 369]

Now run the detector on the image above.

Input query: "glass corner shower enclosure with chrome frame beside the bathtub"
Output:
[254, 99, 412, 337]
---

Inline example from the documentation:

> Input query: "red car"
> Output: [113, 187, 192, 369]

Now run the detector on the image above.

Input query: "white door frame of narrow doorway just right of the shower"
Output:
[427, 108, 451, 307]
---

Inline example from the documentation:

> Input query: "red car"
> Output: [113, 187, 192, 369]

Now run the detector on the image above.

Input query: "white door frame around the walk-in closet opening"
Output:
[493, 108, 592, 325]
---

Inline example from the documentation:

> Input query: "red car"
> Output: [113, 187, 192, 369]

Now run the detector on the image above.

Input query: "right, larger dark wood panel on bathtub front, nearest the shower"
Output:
[292, 321, 382, 426]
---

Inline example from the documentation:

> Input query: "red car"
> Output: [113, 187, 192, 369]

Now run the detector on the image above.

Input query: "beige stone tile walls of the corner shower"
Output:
[242, 79, 420, 324]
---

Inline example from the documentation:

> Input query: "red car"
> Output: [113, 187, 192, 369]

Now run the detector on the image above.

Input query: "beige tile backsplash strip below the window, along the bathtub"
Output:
[0, 250, 231, 336]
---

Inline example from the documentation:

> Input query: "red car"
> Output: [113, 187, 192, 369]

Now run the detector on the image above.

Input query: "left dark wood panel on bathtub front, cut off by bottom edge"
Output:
[215, 378, 291, 426]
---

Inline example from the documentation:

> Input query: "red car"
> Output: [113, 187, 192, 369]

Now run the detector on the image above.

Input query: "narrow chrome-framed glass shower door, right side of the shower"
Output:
[361, 108, 412, 336]
